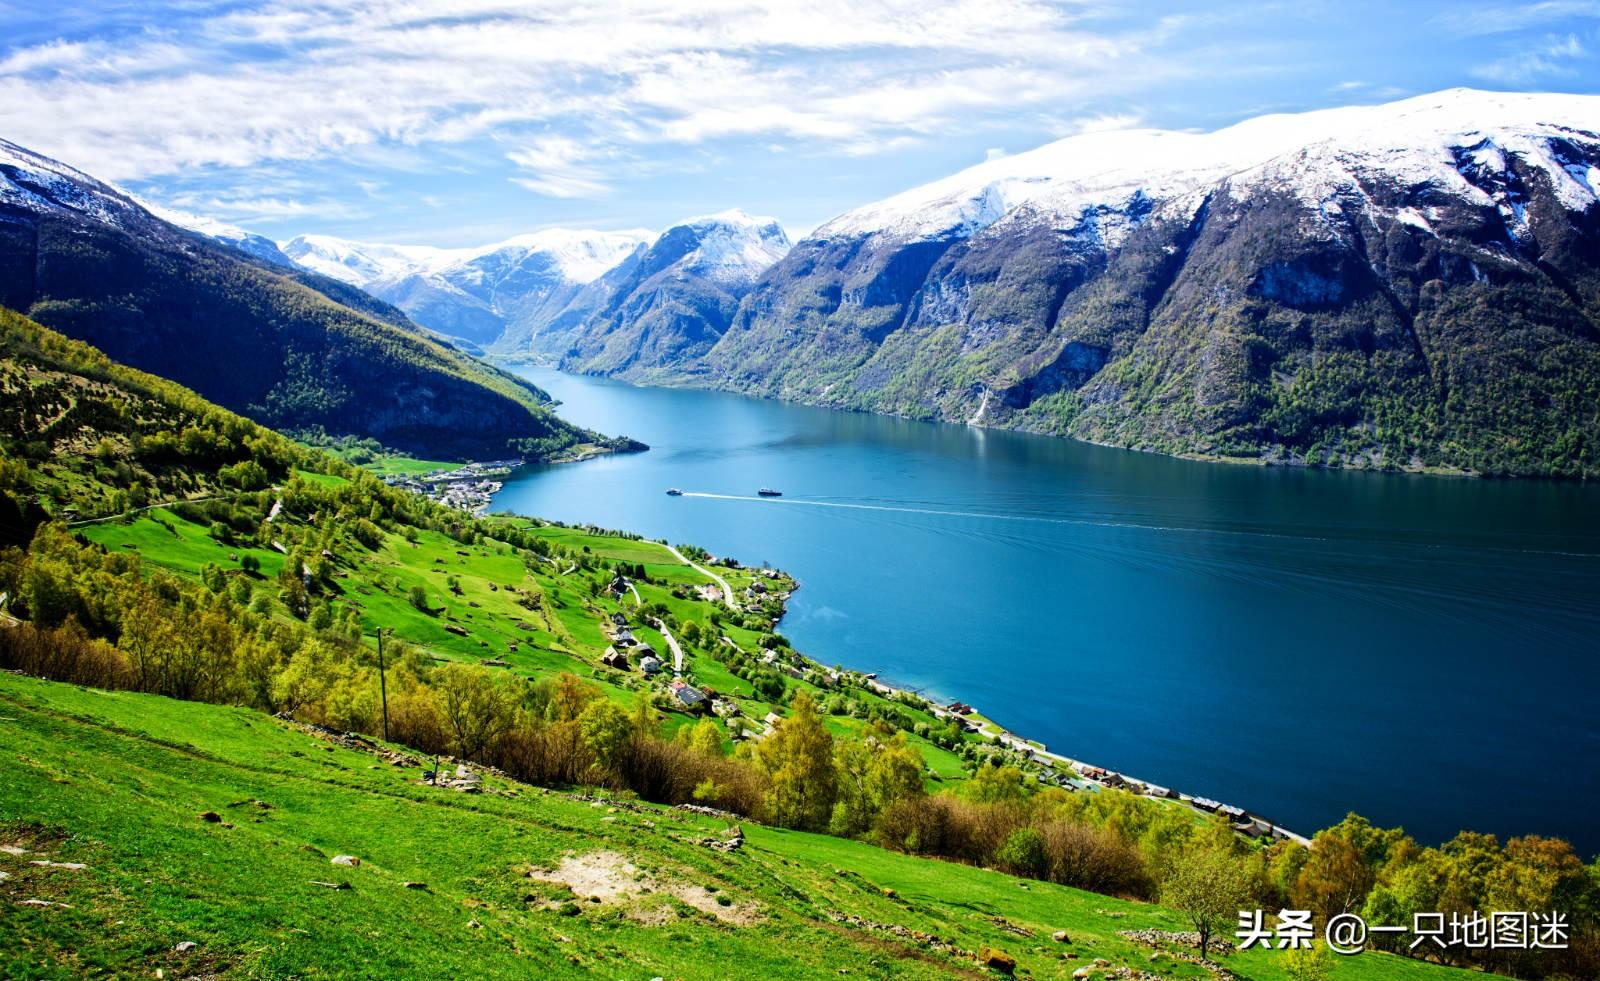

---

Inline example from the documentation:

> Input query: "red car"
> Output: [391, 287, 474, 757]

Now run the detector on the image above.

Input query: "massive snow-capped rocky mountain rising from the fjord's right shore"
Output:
[707, 90, 1600, 472]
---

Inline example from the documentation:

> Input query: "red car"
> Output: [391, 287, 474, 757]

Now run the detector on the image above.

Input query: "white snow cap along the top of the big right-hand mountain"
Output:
[816, 88, 1600, 238]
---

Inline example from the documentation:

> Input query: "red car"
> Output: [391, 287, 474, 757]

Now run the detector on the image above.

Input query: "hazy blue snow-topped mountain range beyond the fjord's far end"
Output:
[270, 211, 790, 373]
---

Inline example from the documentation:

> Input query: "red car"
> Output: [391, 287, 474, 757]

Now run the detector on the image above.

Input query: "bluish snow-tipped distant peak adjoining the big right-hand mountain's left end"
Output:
[556, 210, 790, 381]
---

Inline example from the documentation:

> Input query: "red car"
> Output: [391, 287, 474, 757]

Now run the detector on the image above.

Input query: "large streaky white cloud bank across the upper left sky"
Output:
[0, 0, 1171, 189]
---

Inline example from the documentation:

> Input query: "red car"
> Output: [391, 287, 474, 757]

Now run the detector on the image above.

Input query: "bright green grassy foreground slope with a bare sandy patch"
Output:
[0, 675, 1464, 981]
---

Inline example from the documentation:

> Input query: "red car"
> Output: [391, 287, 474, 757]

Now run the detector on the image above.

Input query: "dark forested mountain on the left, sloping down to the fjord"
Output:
[0, 141, 597, 456]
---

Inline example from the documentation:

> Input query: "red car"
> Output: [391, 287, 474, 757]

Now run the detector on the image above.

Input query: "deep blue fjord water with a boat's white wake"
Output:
[494, 368, 1600, 856]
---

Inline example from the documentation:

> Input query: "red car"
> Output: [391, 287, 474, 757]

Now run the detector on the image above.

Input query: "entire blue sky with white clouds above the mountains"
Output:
[0, 0, 1600, 246]
